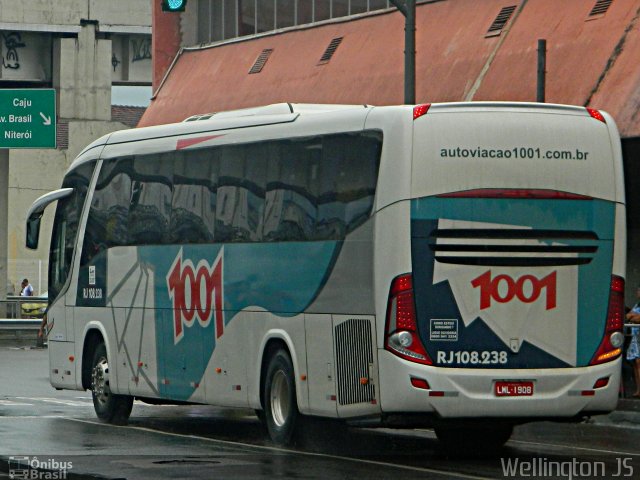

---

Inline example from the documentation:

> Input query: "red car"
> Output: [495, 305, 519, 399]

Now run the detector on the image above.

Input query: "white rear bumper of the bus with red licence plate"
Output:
[378, 350, 622, 420]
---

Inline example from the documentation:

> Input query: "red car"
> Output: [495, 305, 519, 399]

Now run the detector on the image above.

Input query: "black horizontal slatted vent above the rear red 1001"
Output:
[429, 228, 599, 267]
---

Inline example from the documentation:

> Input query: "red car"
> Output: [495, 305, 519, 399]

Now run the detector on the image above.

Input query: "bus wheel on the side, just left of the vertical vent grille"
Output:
[263, 349, 300, 445]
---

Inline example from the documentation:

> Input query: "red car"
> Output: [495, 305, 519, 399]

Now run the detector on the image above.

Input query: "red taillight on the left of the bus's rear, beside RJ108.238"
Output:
[385, 274, 433, 365]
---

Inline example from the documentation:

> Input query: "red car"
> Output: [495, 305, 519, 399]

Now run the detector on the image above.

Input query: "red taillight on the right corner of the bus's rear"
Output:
[589, 275, 624, 365]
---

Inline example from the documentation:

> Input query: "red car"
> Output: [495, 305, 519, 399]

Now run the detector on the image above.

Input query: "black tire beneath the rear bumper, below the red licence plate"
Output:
[434, 423, 513, 456]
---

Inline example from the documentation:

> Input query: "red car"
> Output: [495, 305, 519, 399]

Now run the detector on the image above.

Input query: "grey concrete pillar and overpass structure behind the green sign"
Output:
[0, 0, 152, 293]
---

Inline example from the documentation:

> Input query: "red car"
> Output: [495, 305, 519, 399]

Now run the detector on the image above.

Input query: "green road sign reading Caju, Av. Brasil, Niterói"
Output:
[0, 88, 56, 148]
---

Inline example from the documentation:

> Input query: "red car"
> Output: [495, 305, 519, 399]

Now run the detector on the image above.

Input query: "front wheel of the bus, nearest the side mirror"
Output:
[91, 342, 133, 425]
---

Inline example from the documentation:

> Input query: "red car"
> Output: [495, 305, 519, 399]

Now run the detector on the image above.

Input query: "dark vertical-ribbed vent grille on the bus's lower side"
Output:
[334, 319, 375, 405]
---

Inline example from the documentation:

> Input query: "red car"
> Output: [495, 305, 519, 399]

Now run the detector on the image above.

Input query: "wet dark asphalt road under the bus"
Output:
[0, 346, 640, 480]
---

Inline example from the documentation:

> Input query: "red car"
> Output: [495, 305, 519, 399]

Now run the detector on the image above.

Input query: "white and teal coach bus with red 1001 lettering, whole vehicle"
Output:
[27, 102, 625, 448]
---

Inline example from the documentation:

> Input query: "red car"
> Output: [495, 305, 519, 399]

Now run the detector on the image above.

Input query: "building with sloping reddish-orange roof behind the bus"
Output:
[140, 0, 640, 303]
